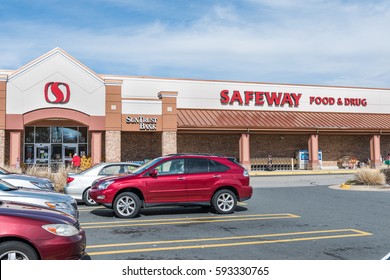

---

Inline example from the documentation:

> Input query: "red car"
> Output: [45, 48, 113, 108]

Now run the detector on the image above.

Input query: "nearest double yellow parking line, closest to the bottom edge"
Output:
[87, 229, 372, 256]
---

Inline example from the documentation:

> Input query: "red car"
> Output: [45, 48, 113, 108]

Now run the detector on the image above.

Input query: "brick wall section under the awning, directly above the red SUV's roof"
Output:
[177, 133, 241, 158]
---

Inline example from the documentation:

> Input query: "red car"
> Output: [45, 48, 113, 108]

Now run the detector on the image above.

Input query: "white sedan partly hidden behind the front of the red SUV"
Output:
[64, 162, 140, 206]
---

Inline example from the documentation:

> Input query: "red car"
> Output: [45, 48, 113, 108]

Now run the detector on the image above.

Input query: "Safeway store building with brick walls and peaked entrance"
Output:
[0, 48, 390, 169]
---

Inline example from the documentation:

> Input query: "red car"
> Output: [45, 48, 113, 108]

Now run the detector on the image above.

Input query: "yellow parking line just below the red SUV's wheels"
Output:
[81, 213, 300, 229]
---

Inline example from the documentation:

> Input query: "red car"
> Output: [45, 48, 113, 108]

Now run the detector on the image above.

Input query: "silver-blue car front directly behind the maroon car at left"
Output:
[0, 180, 79, 219]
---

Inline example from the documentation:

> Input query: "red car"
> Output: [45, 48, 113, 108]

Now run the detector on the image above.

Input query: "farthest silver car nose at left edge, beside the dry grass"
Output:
[0, 167, 54, 191]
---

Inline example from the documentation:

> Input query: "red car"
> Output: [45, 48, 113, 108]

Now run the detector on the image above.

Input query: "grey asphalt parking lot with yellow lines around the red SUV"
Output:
[79, 175, 390, 260]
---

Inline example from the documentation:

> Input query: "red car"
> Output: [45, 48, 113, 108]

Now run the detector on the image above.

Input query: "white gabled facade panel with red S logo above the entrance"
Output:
[6, 49, 106, 116]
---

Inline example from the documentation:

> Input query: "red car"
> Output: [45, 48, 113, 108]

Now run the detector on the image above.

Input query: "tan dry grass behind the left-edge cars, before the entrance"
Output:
[4, 166, 79, 192]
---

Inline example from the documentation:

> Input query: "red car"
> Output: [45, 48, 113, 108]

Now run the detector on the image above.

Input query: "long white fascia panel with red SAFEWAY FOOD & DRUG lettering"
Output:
[122, 77, 390, 115]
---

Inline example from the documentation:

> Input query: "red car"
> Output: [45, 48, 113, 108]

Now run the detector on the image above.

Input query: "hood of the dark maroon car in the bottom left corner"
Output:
[0, 200, 77, 225]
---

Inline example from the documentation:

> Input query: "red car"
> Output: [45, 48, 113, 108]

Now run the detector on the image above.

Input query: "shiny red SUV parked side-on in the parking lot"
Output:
[90, 154, 252, 218]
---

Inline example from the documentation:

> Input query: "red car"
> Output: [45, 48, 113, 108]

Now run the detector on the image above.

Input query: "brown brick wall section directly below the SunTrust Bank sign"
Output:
[121, 132, 162, 161]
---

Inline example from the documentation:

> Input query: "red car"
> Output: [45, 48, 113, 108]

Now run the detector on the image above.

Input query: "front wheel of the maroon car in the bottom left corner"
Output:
[0, 241, 38, 261]
